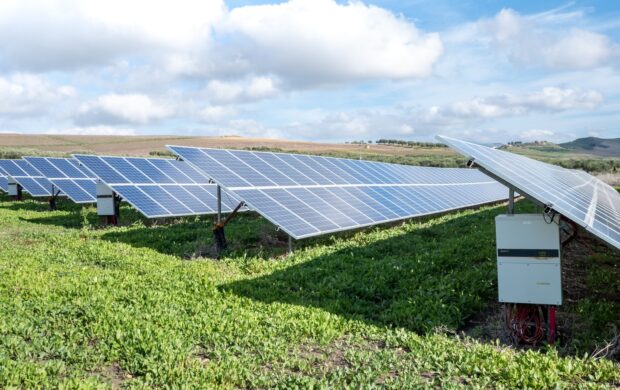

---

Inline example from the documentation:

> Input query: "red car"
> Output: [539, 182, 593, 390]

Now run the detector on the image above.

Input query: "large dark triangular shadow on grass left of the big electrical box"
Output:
[221, 207, 505, 332]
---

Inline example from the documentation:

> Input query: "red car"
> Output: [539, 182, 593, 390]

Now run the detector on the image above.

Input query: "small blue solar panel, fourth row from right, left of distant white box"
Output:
[24, 157, 97, 203]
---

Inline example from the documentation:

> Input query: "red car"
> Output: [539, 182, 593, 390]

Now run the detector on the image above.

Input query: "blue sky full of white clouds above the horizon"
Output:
[0, 0, 620, 143]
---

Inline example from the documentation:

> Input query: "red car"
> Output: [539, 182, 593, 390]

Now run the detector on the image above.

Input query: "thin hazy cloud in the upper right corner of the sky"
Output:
[474, 9, 618, 69]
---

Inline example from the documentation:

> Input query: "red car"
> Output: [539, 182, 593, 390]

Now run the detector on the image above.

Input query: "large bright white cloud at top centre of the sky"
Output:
[221, 0, 442, 84]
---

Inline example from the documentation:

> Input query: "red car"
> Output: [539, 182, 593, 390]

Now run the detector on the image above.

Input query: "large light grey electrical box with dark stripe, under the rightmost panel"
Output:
[495, 214, 562, 305]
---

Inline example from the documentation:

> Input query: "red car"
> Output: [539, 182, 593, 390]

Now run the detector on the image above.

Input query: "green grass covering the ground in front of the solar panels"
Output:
[0, 197, 620, 389]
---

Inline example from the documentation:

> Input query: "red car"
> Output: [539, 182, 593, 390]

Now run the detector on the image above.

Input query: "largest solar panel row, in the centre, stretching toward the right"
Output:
[168, 146, 508, 239]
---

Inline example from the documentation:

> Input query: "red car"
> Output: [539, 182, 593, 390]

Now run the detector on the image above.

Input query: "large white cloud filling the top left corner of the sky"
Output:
[0, 0, 226, 70]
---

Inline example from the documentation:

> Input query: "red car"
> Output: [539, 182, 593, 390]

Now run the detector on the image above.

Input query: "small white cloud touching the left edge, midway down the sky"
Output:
[0, 73, 76, 115]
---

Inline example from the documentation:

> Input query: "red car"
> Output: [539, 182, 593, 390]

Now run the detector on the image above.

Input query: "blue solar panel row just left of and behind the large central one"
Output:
[74, 155, 238, 218]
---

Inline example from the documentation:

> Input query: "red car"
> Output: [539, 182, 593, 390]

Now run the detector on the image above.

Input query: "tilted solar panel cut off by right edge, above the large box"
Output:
[437, 136, 620, 249]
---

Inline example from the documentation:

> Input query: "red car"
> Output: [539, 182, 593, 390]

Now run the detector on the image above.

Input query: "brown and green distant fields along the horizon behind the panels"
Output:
[0, 134, 620, 177]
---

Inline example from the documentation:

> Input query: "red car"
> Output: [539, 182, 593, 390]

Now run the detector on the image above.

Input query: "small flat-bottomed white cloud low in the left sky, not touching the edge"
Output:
[78, 94, 174, 124]
